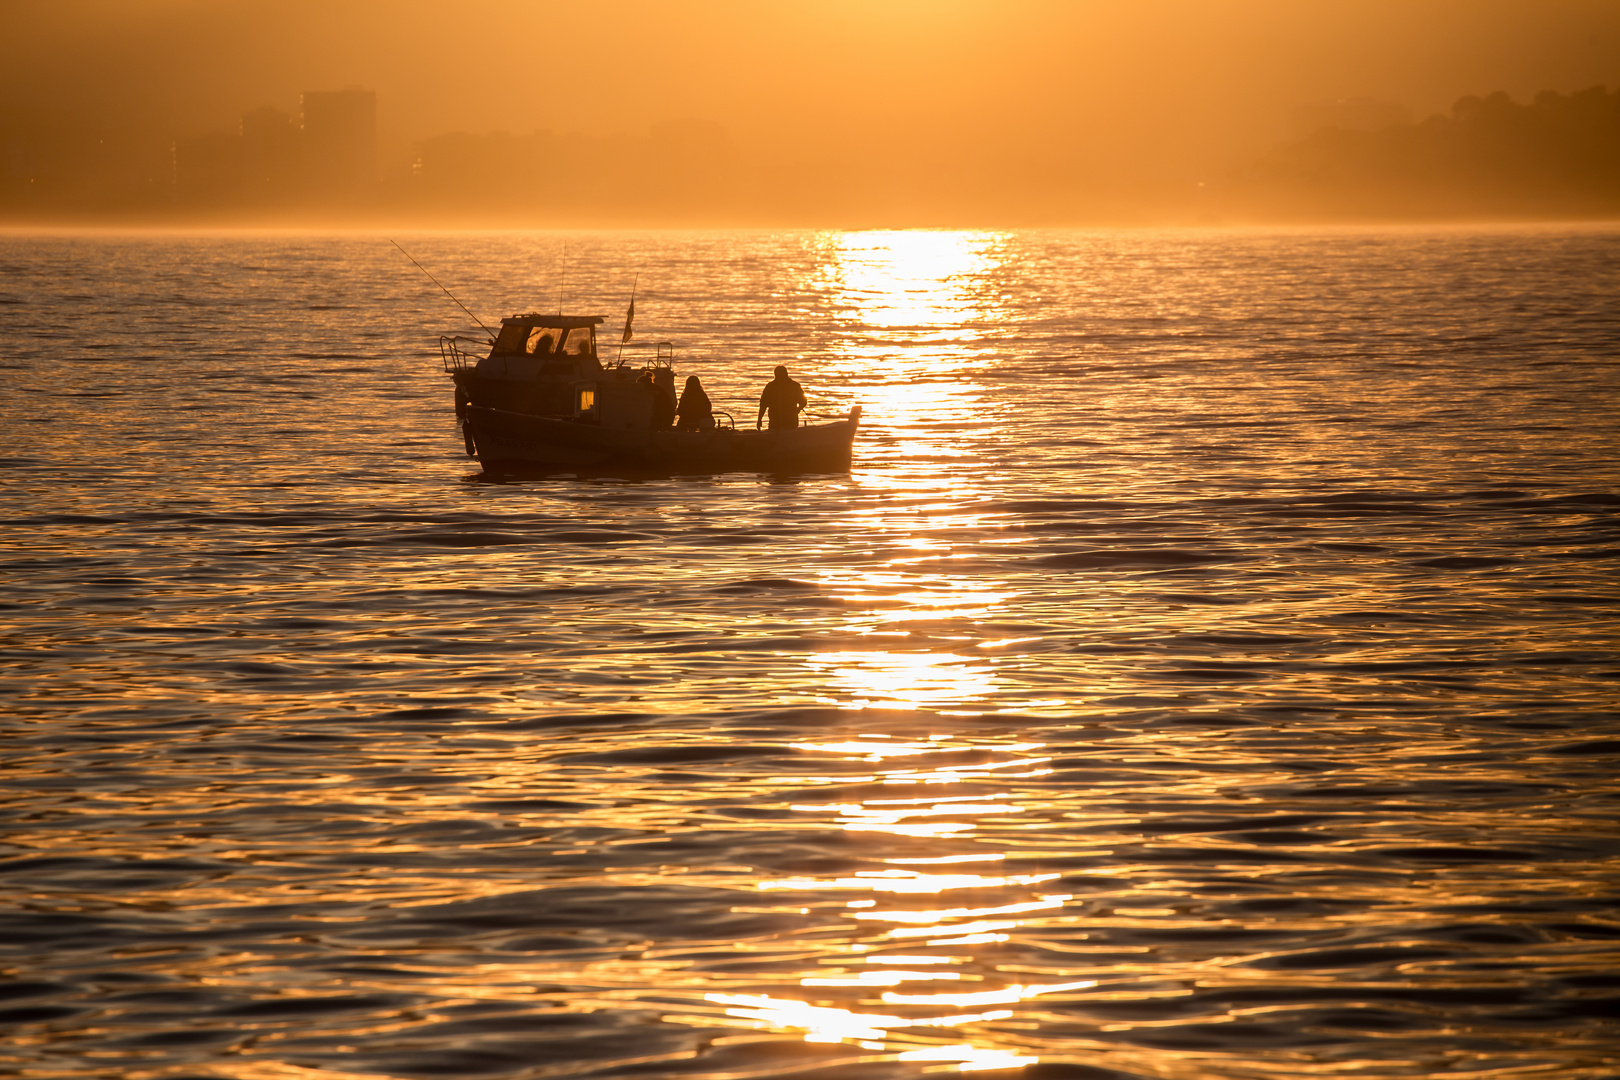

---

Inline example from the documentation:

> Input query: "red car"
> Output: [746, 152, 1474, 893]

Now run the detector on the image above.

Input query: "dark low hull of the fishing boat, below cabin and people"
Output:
[465, 405, 860, 473]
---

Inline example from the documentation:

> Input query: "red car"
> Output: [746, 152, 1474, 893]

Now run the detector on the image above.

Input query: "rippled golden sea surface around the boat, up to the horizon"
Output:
[0, 228, 1620, 1080]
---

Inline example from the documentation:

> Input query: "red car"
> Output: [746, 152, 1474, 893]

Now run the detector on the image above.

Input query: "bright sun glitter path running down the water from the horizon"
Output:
[664, 233, 1092, 1072]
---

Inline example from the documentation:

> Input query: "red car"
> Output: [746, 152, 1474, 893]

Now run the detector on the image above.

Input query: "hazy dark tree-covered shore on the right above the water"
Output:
[1225, 86, 1620, 219]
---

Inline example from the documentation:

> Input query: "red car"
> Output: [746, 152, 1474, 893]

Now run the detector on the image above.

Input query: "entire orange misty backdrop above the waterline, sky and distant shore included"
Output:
[0, 0, 1620, 228]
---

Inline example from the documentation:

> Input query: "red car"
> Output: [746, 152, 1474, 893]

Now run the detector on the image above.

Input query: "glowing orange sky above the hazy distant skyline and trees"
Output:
[0, 0, 1620, 202]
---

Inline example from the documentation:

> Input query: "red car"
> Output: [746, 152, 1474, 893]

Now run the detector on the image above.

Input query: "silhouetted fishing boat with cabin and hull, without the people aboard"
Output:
[439, 313, 860, 473]
